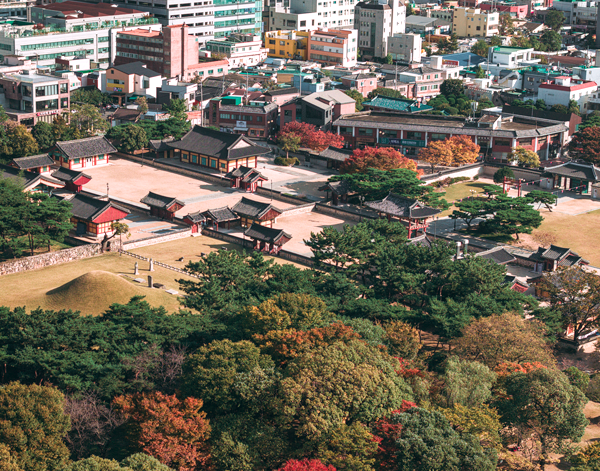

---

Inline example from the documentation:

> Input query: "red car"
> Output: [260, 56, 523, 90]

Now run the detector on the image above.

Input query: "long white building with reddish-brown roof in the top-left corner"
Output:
[0, 1, 160, 68]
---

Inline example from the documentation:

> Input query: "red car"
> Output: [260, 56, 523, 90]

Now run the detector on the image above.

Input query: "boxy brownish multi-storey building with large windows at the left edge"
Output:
[0, 73, 70, 127]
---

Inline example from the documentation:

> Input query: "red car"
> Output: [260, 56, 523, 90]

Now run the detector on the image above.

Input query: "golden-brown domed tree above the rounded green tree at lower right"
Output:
[452, 312, 556, 369]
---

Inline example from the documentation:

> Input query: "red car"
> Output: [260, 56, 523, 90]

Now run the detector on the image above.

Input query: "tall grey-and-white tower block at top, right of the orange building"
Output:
[354, 0, 406, 59]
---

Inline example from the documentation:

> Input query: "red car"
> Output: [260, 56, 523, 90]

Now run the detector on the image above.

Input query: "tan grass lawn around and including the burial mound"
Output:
[0, 237, 306, 315]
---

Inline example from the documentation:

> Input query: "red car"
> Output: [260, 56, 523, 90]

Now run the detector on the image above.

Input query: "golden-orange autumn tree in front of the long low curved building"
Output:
[419, 136, 480, 173]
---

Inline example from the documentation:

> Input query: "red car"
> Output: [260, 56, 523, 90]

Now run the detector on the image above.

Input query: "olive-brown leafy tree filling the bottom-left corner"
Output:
[0, 382, 69, 471]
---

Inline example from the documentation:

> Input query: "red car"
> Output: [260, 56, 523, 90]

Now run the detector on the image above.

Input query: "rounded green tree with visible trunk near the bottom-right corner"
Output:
[496, 368, 588, 468]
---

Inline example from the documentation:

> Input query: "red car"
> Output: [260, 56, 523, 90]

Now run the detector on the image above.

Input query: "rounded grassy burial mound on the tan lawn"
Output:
[46, 270, 147, 314]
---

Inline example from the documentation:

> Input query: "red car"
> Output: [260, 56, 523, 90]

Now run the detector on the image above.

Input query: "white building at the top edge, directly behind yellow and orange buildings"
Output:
[268, 0, 358, 31]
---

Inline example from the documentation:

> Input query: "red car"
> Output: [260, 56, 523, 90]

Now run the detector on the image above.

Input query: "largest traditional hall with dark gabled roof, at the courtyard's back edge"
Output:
[167, 126, 271, 173]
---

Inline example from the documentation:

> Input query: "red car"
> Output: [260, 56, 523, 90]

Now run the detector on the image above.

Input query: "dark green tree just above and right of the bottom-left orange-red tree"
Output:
[181, 340, 274, 414]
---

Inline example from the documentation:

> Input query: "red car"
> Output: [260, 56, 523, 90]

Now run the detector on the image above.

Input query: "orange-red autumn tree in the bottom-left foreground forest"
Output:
[114, 392, 210, 471]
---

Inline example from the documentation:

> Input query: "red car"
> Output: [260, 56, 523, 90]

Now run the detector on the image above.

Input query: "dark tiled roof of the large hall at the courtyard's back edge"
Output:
[167, 125, 277, 160]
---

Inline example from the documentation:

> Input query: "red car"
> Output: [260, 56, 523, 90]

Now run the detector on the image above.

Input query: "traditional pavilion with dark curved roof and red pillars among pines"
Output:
[365, 192, 441, 239]
